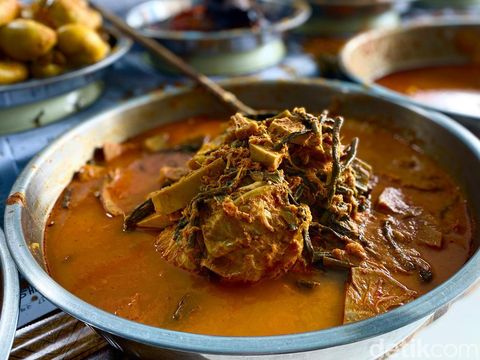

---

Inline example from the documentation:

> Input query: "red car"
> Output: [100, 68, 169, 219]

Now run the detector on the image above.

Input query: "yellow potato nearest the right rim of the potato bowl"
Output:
[57, 24, 110, 65]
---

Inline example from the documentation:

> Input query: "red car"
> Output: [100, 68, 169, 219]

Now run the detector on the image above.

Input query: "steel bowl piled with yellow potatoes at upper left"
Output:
[0, 0, 131, 132]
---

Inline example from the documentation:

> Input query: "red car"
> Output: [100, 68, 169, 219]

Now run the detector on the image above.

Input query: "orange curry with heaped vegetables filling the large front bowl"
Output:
[44, 108, 472, 336]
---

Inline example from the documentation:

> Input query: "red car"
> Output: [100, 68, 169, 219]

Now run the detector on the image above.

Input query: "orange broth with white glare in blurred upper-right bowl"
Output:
[376, 64, 480, 116]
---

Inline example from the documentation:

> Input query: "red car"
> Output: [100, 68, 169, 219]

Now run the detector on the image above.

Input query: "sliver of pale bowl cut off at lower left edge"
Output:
[0, 229, 20, 360]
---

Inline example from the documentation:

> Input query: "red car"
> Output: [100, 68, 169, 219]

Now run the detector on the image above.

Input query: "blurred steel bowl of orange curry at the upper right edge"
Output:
[340, 19, 480, 133]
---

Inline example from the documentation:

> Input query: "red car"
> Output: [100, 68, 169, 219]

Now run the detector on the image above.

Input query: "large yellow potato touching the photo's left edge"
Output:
[0, 19, 57, 61]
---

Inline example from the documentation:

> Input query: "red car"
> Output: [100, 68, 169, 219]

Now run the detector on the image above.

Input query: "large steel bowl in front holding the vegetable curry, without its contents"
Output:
[5, 80, 480, 360]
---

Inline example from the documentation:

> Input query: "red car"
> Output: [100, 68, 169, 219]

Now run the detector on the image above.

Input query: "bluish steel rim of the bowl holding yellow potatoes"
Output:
[0, 27, 132, 110]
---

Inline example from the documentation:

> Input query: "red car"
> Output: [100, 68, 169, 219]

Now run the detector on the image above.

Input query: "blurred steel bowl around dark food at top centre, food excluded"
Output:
[126, 0, 310, 75]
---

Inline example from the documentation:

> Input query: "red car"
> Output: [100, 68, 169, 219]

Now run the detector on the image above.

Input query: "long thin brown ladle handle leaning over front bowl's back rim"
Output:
[90, 2, 256, 114]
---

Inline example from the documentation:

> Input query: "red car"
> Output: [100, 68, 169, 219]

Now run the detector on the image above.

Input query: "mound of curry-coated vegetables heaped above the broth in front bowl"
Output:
[125, 108, 378, 283]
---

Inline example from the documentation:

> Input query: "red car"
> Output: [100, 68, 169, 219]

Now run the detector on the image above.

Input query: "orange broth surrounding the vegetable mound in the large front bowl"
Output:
[45, 118, 471, 336]
